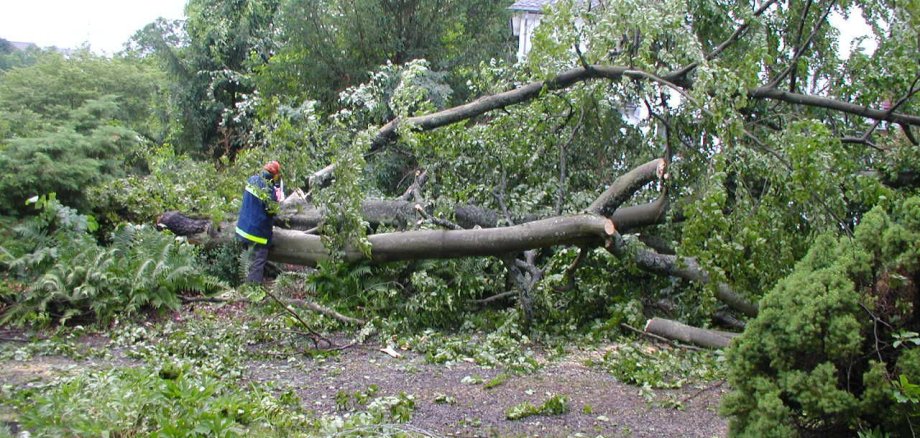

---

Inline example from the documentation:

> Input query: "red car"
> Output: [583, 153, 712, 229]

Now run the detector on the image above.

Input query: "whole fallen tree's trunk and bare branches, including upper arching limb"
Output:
[160, 0, 920, 332]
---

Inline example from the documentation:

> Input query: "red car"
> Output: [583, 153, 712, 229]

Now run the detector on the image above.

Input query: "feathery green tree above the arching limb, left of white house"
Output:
[263, 0, 510, 104]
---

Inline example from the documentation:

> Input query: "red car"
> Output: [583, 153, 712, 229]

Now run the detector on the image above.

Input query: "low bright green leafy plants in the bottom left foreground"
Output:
[5, 367, 311, 436]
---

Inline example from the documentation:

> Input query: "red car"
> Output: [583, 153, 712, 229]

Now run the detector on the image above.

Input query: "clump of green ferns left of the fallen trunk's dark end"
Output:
[2, 195, 224, 324]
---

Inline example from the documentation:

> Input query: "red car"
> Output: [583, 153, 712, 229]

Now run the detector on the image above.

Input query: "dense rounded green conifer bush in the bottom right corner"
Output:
[722, 197, 920, 436]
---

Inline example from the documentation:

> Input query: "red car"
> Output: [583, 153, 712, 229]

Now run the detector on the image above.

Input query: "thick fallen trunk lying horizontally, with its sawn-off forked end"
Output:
[157, 159, 757, 316]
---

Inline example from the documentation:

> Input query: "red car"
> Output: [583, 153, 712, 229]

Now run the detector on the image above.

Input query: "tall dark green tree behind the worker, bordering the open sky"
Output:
[131, 0, 278, 157]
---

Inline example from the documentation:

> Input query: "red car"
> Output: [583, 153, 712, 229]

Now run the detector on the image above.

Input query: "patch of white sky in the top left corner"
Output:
[0, 0, 186, 54]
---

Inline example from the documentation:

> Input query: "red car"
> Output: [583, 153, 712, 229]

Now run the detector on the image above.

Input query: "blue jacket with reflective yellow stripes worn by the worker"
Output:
[236, 175, 278, 245]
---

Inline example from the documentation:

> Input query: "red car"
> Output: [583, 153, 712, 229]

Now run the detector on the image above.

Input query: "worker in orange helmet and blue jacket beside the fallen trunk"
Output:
[236, 161, 284, 283]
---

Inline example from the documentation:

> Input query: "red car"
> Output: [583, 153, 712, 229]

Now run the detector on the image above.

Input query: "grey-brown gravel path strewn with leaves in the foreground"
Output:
[0, 334, 727, 437]
